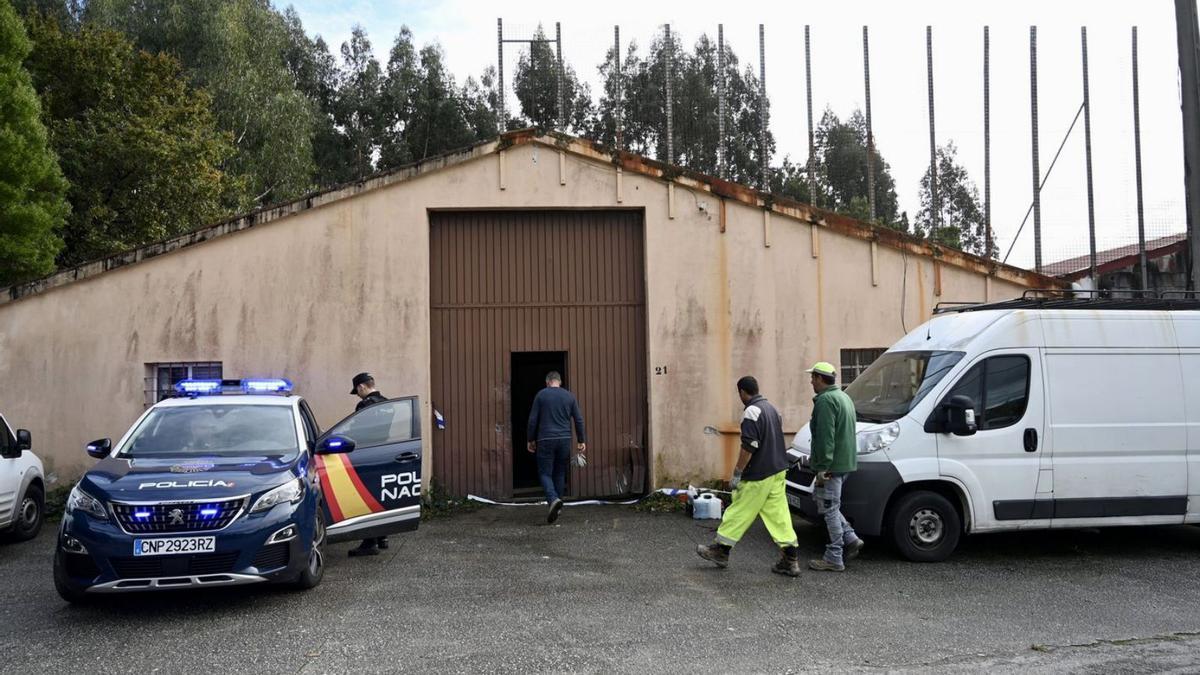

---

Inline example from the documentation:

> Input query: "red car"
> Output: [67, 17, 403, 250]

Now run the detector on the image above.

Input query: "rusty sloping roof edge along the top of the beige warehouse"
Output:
[0, 129, 1066, 305]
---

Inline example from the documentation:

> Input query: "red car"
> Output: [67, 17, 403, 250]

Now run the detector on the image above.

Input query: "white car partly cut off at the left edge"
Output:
[0, 403, 46, 542]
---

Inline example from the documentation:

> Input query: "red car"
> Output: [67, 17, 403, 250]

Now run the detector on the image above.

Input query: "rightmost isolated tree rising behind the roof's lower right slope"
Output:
[916, 142, 997, 258]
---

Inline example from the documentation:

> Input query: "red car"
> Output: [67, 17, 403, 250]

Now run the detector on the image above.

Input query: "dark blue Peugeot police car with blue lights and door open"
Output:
[54, 378, 421, 602]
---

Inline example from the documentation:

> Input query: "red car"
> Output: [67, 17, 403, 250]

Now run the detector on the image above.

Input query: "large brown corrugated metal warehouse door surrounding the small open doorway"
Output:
[430, 210, 647, 498]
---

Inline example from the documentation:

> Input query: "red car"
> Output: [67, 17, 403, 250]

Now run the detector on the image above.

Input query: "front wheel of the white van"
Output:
[889, 490, 962, 562]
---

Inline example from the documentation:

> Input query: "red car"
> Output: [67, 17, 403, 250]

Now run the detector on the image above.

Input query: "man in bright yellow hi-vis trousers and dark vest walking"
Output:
[696, 375, 800, 577]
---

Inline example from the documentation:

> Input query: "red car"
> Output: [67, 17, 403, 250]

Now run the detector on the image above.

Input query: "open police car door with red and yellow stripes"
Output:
[316, 396, 421, 542]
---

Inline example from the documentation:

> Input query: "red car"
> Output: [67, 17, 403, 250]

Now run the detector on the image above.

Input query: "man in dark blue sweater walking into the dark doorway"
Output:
[526, 371, 587, 522]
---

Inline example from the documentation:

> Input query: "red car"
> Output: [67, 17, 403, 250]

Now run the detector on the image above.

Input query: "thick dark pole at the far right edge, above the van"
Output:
[1175, 0, 1200, 291]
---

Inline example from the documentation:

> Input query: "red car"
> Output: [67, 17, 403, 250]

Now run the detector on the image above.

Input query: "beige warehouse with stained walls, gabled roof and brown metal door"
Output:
[0, 131, 1056, 498]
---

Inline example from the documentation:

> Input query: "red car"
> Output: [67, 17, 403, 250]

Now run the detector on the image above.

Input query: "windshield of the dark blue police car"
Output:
[120, 405, 300, 458]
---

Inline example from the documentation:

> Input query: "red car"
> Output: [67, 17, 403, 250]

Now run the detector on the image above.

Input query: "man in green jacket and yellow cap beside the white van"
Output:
[805, 362, 863, 572]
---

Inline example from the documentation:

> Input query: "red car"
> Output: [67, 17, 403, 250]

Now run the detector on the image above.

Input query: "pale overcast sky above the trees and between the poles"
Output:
[283, 0, 1186, 267]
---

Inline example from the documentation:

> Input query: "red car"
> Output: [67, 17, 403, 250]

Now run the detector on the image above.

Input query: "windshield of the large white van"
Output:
[846, 352, 962, 423]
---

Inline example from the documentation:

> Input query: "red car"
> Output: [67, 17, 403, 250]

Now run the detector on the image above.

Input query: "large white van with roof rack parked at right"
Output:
[787, 299, 1200, 561]
